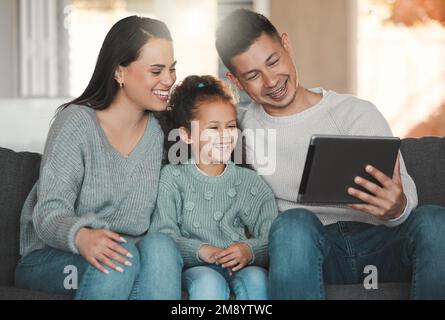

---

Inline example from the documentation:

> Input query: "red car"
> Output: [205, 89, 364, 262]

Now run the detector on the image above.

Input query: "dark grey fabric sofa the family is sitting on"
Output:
[0, 137, 445, 300]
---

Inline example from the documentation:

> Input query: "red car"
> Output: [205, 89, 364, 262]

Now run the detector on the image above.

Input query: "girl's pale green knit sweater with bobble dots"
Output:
[150, 162, 278, 267]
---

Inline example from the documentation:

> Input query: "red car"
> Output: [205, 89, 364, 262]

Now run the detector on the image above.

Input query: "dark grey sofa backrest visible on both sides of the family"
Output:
[0, 137, 445, 286]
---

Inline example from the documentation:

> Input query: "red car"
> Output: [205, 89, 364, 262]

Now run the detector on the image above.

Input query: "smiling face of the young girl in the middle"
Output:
[186, 99, 238, 164]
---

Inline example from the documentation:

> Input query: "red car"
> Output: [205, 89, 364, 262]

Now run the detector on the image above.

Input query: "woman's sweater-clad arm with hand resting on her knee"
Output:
[32, 109, 131, 273]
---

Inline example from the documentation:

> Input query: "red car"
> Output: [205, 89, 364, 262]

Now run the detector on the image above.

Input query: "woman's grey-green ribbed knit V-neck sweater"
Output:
[20, 105, 163, 256]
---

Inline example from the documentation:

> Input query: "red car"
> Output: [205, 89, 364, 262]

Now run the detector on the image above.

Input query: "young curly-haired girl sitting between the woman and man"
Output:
[151, 76, 278, 300]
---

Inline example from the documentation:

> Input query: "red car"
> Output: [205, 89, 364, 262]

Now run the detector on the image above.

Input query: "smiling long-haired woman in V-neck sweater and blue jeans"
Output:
[15, 16, 183, 299]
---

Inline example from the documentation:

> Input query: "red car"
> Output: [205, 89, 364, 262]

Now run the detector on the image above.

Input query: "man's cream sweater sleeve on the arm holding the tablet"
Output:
[336, 99, 418, 227]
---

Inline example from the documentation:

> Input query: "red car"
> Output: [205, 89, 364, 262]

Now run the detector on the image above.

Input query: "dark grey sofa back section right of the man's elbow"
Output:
[401, 137, 445, 206]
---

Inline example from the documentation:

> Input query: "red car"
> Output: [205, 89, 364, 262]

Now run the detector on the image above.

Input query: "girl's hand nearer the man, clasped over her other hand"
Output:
[215, 242, 253, 272]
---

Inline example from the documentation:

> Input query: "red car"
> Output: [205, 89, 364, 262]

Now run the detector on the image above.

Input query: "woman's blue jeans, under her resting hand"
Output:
[15, 233, 183, 300]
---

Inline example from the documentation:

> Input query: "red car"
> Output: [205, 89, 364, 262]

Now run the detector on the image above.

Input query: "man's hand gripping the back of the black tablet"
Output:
[348, 155, 407, 220]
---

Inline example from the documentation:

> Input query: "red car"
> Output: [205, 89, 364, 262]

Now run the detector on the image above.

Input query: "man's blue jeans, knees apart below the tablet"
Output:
[269, 206, 445, 299]
